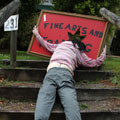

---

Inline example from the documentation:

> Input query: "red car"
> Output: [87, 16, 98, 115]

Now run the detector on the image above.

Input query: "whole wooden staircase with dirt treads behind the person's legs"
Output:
[0, 60, 120, 120]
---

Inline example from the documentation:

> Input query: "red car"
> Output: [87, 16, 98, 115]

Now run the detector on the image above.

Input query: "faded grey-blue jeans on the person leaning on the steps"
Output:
[35, 68, 81, 120]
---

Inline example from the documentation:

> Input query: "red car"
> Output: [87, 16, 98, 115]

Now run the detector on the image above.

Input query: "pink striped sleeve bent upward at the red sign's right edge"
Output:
[79, 47, 106, 67]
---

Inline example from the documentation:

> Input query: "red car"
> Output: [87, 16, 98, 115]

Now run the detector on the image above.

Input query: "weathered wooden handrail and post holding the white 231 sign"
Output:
[0, 0, 20, 68]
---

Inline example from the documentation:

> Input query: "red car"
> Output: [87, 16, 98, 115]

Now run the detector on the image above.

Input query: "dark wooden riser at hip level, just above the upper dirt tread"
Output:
[0, 69, 113, 82]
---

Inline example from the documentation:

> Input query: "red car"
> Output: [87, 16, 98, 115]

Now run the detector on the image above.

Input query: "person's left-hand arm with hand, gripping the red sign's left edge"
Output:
[32, 26, 58, 52]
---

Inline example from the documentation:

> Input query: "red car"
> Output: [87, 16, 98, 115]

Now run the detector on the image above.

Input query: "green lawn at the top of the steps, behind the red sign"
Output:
[0, 51, 120, 73]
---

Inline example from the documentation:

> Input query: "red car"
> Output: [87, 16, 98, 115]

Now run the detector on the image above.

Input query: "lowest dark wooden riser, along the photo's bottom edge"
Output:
[0, 112, 120, 120]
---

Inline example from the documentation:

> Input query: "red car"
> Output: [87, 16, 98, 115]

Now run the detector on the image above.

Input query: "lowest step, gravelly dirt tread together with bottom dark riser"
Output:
[0, 98, 120, 120]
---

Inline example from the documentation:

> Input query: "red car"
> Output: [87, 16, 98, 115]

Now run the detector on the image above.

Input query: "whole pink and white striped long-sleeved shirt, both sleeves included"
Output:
[36, 34, 106, 71]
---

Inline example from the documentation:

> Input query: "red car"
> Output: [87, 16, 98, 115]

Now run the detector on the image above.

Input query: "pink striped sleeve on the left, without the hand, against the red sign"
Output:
[36, 34, 58, 53]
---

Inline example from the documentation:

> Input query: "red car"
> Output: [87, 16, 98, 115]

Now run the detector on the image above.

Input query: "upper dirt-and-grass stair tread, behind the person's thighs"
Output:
[0, 80, 120, 89]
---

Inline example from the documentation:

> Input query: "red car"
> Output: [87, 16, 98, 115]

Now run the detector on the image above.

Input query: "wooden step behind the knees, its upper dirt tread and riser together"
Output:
[0, 81, 120, 101]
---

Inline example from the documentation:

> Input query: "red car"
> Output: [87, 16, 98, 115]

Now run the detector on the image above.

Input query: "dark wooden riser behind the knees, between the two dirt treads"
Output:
[0, 87, 120, 101]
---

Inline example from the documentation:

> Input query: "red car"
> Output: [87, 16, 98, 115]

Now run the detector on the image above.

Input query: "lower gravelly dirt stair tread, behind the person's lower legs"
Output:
[0, 98, 120, 112]
